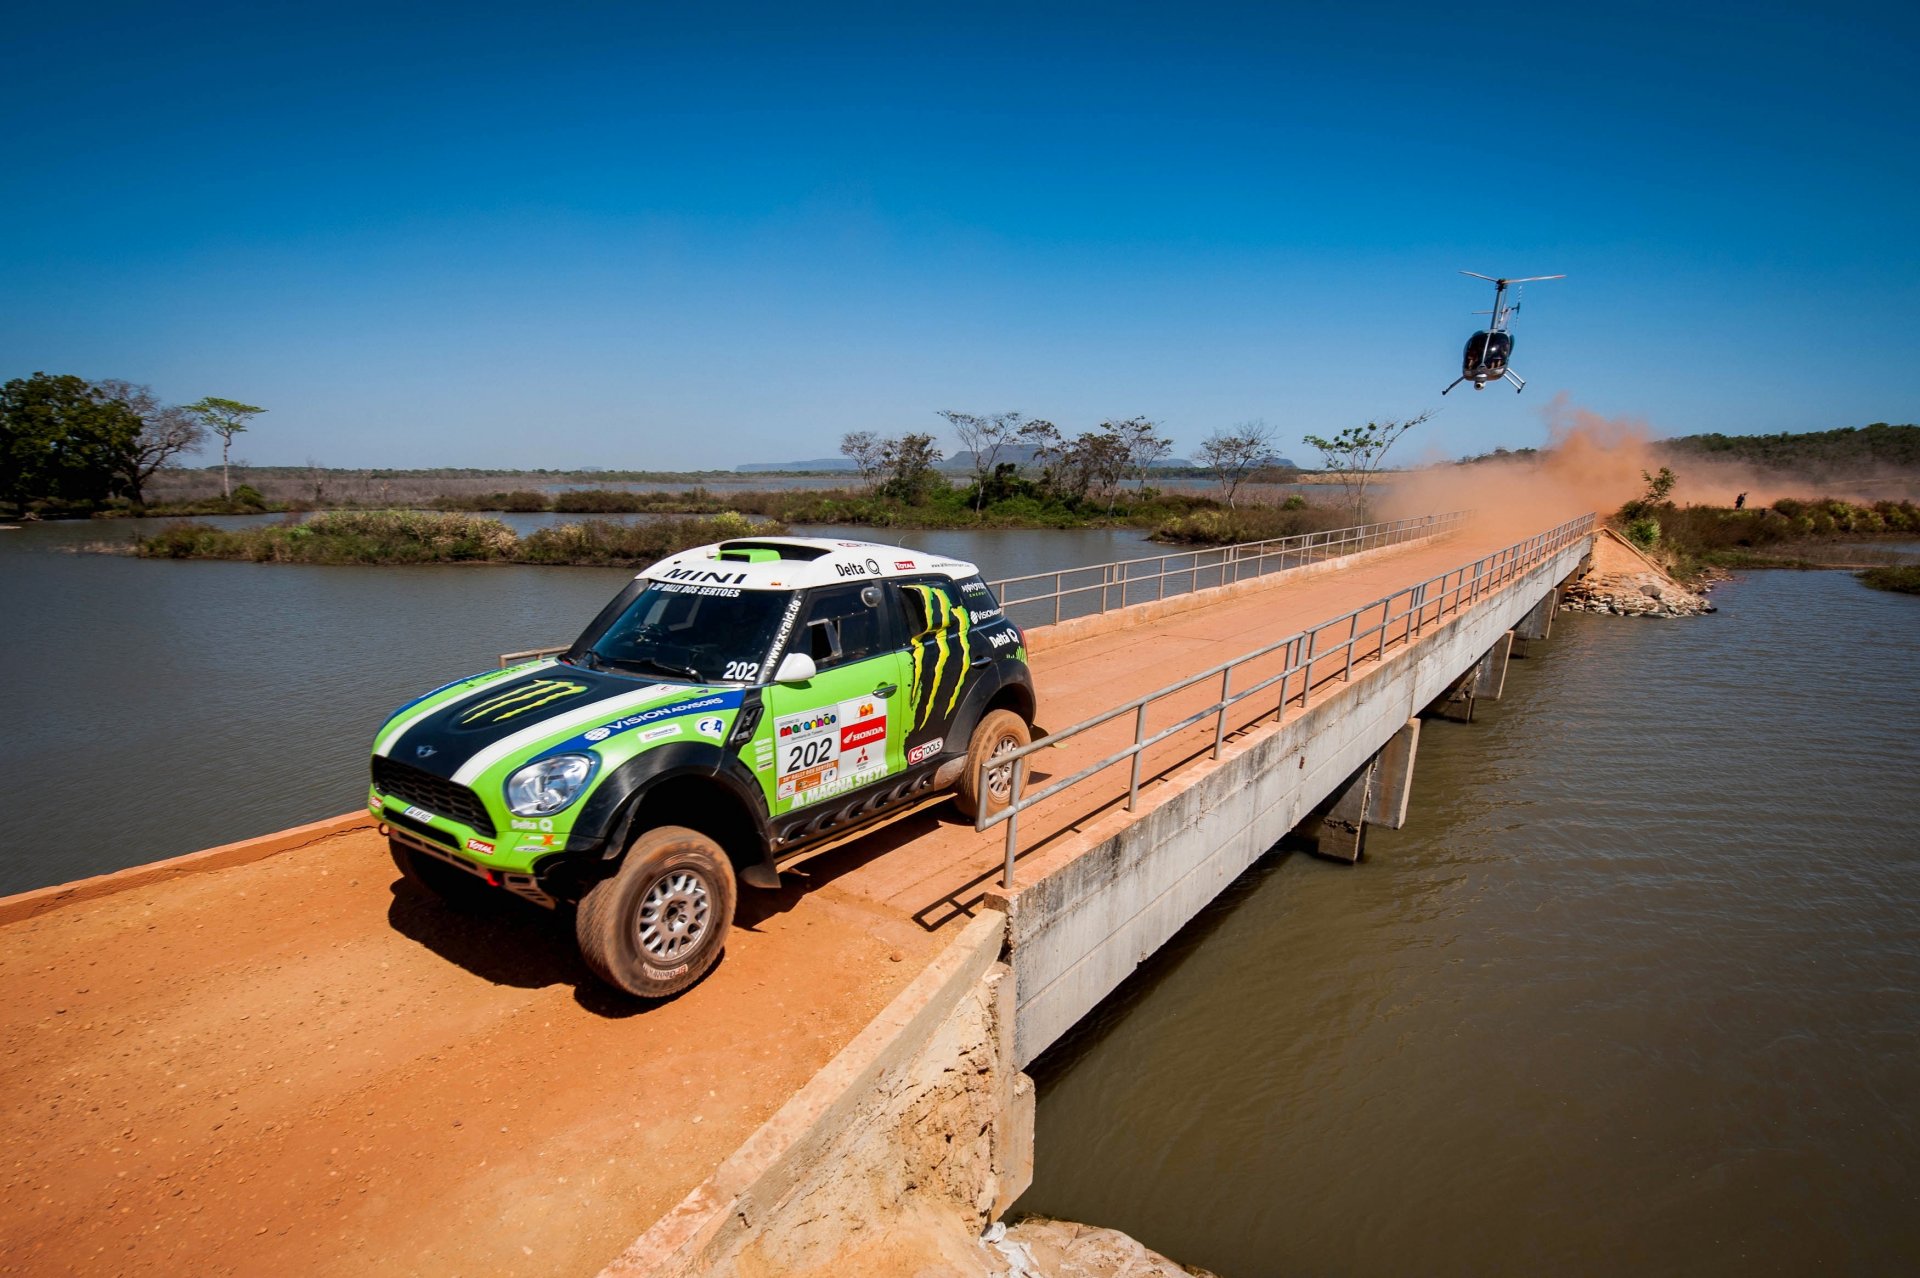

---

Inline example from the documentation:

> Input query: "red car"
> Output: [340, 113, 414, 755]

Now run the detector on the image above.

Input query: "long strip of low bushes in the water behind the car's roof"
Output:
[134, 510, 785, 568]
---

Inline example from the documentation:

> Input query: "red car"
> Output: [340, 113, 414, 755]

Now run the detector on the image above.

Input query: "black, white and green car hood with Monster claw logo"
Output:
[374, 662, 721, 785]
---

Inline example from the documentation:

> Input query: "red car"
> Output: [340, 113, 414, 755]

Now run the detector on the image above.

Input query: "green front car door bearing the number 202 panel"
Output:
[764, 583, 906, 817]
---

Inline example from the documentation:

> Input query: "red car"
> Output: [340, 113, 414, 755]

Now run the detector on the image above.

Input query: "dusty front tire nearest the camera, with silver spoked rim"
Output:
[574, 825, 739, 998]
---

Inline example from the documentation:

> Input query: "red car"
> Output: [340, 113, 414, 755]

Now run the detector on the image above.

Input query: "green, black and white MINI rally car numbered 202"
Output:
[367, 537, 1035, 998]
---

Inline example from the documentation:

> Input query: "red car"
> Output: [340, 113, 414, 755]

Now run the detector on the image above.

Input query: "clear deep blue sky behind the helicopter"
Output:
[0, 4, 1920, 468]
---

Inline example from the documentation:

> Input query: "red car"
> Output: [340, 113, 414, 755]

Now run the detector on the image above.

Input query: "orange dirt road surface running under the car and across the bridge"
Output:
[0, 530, 1543, 1274]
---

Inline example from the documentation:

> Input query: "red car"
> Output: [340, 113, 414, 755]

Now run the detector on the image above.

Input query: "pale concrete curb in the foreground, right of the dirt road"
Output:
[601, 911, 1006, 1278]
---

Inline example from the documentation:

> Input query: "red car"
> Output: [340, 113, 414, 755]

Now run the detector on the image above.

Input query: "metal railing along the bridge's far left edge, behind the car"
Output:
[989, 510, 1473, 626]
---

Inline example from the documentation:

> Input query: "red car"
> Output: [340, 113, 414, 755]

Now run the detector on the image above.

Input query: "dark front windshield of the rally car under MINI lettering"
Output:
[574, 581, 797, 683]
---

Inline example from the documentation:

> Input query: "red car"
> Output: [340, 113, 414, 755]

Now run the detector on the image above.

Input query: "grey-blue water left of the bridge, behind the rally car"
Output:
[0, 514, 1158, 894]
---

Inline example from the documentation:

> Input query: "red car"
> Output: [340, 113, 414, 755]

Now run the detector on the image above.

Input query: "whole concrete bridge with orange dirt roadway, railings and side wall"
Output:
[0, 516, 1594, 1274]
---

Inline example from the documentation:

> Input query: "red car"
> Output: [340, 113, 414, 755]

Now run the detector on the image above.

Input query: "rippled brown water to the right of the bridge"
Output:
[1020, 572, 1920, 1276]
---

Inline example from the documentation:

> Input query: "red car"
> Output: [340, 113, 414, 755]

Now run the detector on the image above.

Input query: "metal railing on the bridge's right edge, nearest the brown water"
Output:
[973, 514, 1594, 890]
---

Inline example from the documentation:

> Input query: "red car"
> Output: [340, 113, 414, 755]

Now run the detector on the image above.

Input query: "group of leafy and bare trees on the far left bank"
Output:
[0, 372, 267, 514]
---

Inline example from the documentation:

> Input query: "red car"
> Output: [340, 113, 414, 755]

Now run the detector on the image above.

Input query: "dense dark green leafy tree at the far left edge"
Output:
[0, 372, 140, 510]
